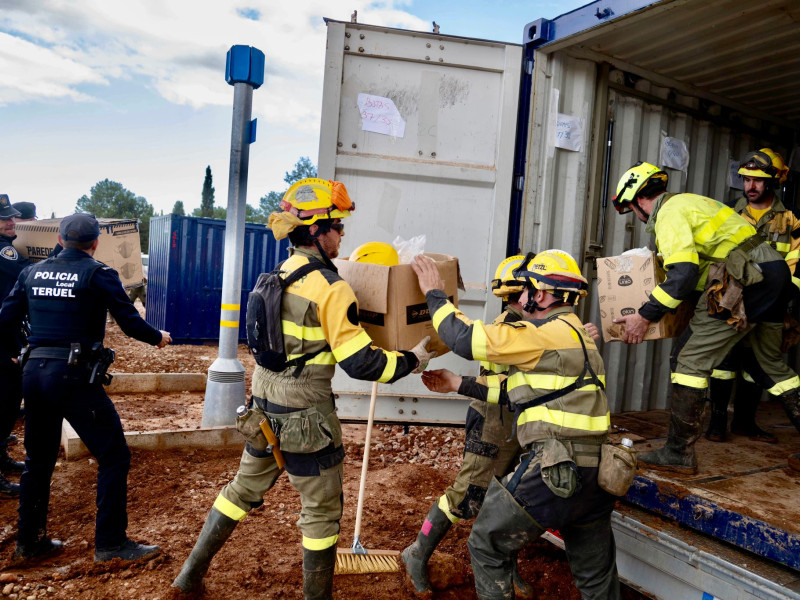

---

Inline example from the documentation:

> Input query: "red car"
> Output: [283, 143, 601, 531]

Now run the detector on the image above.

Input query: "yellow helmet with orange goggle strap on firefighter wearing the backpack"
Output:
[280, 177, 355, 225]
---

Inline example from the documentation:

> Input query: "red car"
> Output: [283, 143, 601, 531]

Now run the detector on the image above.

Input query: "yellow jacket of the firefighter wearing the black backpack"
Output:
[252, 248, 417, 408]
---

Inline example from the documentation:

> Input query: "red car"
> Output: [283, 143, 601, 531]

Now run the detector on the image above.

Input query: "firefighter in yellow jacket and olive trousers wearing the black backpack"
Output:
[172, 179, 431, 600]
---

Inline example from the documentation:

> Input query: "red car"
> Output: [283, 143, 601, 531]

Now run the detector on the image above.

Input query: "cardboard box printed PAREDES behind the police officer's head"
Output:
[14, 219, 142, 287]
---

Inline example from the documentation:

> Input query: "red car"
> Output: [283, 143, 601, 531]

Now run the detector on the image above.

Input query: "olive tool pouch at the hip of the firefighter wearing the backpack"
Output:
[267, 407, 342, 454]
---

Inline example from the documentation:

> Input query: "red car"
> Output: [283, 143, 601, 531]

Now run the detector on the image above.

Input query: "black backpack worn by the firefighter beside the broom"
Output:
[245, 260, 325, 377]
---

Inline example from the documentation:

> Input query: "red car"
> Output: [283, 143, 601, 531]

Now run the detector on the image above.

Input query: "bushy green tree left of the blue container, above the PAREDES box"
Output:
[75, 179, 155, 252]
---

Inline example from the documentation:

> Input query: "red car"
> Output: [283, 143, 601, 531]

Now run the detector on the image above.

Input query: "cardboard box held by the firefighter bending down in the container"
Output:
[597, 252, 694, 342]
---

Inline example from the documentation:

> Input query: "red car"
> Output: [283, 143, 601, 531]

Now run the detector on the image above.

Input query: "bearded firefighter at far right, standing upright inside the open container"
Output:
[706, 148, 800, 444]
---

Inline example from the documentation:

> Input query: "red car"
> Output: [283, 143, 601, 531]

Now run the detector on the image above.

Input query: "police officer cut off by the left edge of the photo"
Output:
[0, 194, 30, 498]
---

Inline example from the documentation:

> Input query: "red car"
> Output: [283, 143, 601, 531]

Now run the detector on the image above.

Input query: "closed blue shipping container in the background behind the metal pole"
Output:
[147, 214, 289, 344]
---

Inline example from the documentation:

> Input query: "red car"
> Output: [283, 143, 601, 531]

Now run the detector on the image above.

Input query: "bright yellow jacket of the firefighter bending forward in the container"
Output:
[639, 194, 756, 321]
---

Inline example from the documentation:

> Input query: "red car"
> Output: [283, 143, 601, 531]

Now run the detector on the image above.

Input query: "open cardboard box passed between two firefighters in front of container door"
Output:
[333, 253, 463, 355]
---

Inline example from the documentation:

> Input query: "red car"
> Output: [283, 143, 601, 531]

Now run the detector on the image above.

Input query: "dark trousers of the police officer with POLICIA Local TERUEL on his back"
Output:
[19, 358, 131, 549]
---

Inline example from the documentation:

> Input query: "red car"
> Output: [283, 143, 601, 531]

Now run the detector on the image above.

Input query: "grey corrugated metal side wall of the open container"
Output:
[521, 51, 789, 411]
